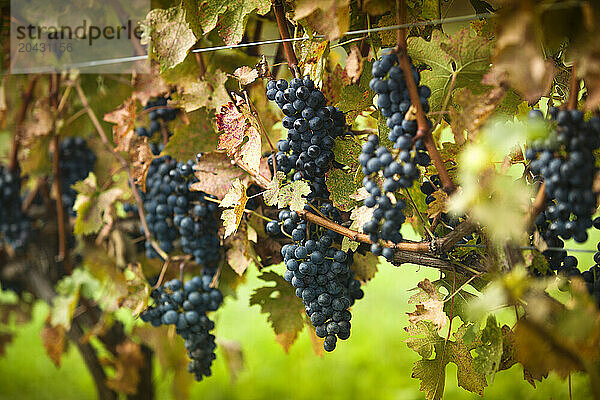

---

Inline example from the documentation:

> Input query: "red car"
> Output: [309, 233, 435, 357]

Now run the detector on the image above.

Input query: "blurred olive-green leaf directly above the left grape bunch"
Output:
[162, 108, 218, 161]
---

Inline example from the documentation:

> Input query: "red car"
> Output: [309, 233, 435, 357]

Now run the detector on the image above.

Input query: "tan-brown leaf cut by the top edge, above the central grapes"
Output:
[294, 0, 350, 40]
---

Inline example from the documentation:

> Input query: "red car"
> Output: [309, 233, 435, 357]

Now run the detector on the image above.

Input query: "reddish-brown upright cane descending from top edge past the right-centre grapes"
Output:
[396, 0, 456, 194]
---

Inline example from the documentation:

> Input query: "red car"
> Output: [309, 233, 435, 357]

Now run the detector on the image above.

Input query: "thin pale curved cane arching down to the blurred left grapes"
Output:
[74, 81, 169, 260]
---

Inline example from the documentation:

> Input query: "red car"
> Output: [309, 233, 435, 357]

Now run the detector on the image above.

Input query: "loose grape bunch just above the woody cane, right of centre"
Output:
[359, 135, 410, 260]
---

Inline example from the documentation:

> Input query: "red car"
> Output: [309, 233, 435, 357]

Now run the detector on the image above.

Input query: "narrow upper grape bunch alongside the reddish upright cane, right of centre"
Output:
[369, 53, 431, 155]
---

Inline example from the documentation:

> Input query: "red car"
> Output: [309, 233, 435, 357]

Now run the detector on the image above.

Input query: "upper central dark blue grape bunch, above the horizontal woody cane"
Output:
[267, 76, 346, 200]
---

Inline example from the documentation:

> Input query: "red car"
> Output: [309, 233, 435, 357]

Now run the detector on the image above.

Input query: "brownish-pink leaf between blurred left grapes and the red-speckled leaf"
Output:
[190, 152, 249, 199]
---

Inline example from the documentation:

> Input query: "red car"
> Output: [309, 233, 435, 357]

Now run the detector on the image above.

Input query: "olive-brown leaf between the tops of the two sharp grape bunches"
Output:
[336, 61, 375, 125]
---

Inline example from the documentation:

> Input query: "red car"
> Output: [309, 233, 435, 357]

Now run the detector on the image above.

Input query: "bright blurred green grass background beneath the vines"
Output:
[0, 225, 600, 400]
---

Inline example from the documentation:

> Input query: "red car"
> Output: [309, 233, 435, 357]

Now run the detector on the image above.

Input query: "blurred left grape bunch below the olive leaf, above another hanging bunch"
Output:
[142, 156, 221, 276]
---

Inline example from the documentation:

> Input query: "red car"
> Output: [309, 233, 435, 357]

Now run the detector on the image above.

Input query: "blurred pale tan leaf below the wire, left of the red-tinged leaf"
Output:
[170, 69, 229, 112]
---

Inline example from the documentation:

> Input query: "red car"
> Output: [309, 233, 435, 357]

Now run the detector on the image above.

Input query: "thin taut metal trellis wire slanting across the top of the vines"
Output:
[11, 13, 496, 74]
